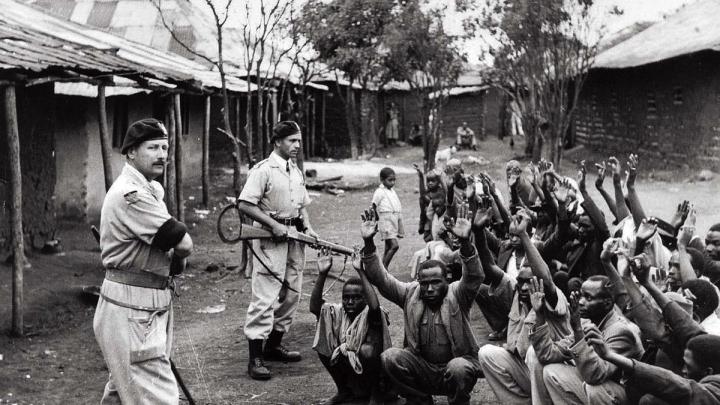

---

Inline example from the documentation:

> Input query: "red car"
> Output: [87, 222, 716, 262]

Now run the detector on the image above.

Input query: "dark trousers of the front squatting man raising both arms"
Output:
[380, 347, 481, 405]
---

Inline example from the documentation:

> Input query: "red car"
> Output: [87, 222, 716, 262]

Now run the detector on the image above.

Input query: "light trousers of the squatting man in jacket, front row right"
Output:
[543, 364, 627, 405]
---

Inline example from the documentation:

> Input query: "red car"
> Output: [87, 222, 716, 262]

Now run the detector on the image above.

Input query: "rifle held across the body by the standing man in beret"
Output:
[217, 204, 354, 256]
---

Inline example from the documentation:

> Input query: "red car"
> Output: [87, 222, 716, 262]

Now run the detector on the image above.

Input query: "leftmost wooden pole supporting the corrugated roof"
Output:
[3, 85, 25, 336]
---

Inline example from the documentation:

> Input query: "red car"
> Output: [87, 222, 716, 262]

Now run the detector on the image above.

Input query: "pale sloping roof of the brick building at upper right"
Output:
[593, 0, 720, 68]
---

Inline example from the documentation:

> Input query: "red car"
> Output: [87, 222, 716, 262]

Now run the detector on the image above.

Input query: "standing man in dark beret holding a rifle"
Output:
[238, 121, 317, 380]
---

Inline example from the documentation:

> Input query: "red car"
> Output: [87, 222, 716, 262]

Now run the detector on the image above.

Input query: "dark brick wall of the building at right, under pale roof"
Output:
[574, 51, 720, 170]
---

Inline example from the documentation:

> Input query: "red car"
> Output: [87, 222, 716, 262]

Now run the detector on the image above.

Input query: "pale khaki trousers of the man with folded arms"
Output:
[93, 289, 180, 405]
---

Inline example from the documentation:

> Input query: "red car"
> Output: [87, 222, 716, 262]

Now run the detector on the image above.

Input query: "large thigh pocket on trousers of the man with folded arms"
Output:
[128, 310, 168, 364]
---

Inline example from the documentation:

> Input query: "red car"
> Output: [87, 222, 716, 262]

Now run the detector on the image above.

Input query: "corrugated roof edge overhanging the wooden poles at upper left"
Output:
[0, 0, 254, 92]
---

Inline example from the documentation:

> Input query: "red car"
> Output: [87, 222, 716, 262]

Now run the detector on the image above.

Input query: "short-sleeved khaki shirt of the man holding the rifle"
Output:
[239, 152, 311, 218]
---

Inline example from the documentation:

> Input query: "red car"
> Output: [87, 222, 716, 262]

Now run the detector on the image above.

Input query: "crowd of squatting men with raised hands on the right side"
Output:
[310, 155, 720, 405]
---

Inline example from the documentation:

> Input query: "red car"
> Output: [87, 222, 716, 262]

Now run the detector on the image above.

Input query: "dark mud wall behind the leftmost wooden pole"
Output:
[0, 83, 56, 251]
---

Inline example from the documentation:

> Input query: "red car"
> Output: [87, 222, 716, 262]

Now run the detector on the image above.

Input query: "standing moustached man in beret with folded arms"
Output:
[93, 118, 193, 404]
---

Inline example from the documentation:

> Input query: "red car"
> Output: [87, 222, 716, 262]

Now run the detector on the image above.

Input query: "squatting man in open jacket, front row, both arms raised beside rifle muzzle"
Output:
[361, 204, 484, 405]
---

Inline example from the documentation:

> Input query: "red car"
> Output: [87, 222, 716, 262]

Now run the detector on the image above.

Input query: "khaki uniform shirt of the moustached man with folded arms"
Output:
[100, 164, 171, 277]
